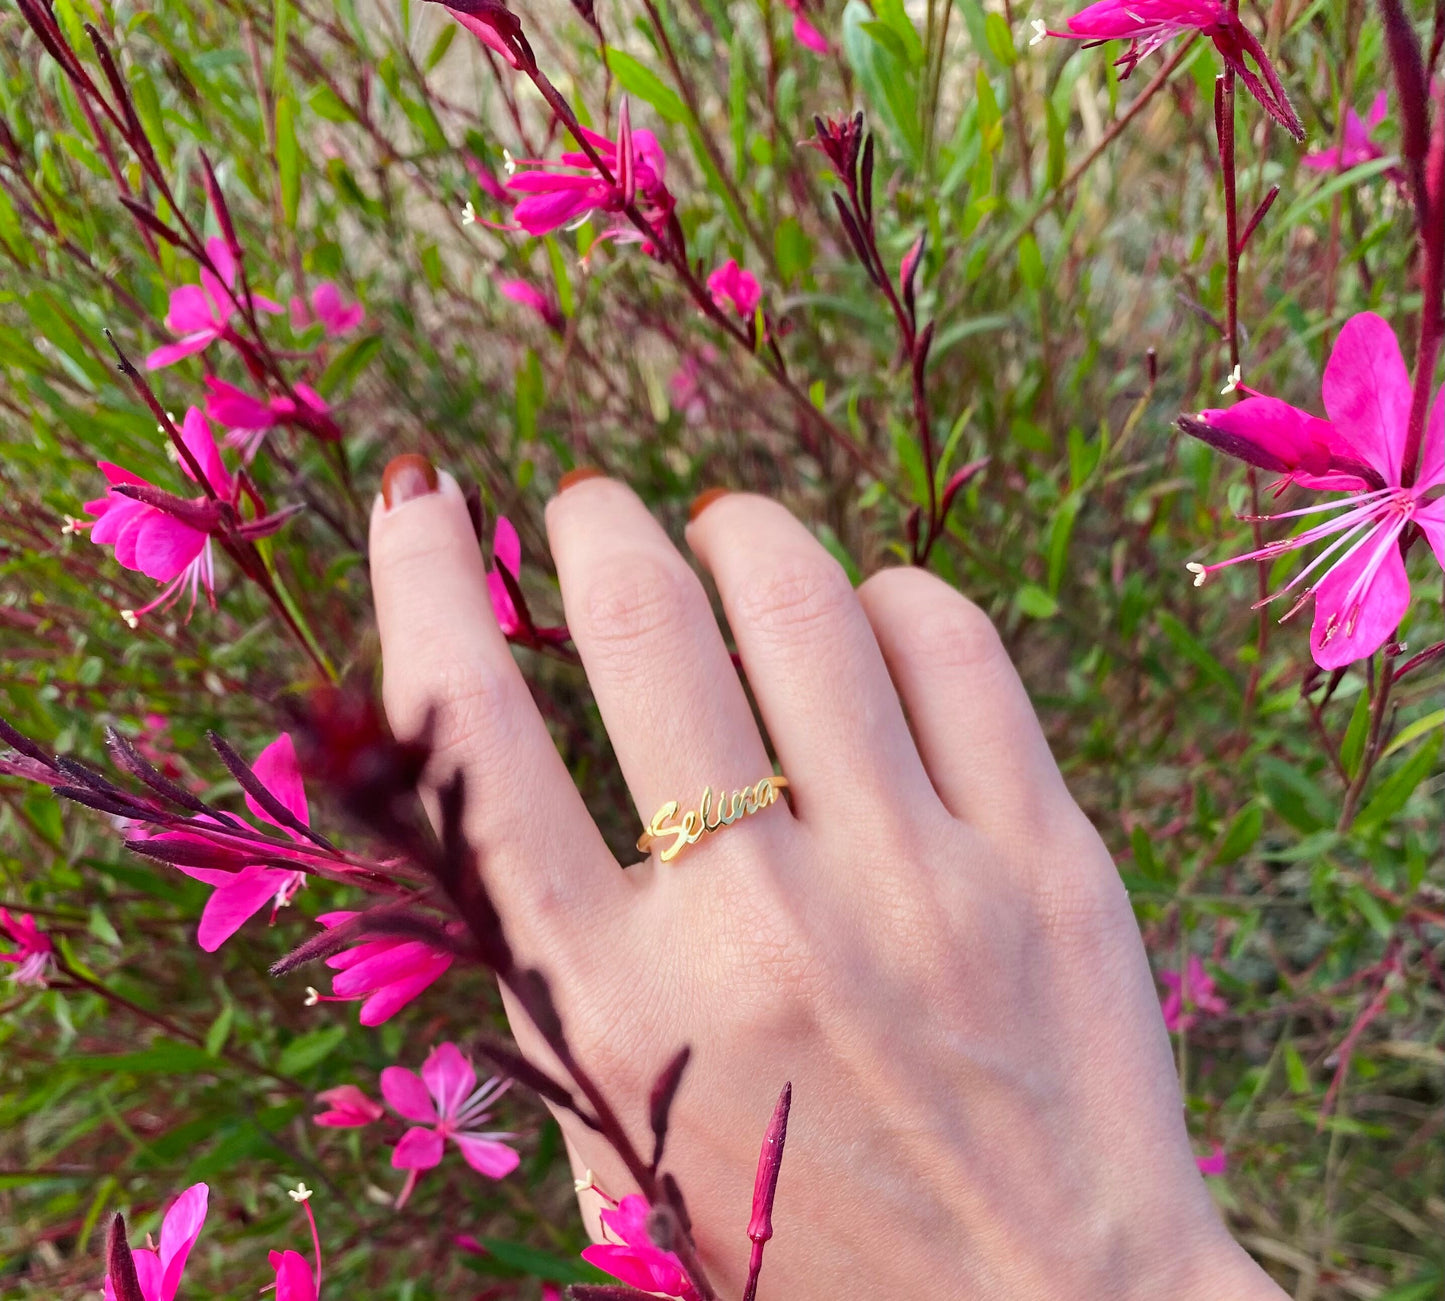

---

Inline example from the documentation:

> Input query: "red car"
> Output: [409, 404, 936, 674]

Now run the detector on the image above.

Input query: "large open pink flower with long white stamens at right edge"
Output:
[1181, 312, 1445, 669]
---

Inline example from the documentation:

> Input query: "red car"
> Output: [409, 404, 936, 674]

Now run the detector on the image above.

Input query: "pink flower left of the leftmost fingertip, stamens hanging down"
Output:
[85, 406, 231, 627]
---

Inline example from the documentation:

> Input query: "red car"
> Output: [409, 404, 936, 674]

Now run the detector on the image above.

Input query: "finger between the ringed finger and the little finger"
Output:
[688, 493, 936, 820]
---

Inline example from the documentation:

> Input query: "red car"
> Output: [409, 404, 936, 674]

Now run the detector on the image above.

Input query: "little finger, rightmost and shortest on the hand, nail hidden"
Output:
[858, 568, 1068, 831]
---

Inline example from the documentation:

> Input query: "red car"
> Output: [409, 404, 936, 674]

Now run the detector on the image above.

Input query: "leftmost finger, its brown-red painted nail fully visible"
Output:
[370, 457, 631, 940]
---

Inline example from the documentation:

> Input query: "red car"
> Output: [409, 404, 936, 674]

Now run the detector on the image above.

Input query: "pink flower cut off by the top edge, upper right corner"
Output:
[1036, 0, 1305, 140]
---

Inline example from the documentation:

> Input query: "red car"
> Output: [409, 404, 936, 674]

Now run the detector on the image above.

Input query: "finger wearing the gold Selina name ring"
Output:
[548, 477, 786, 847]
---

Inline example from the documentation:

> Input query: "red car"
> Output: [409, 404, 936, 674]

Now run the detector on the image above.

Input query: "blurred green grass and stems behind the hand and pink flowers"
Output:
[0, 0, 1445, 1301]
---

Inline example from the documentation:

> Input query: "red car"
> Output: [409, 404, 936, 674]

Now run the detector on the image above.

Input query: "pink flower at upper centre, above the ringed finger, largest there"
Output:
[507, 100, 675, 247]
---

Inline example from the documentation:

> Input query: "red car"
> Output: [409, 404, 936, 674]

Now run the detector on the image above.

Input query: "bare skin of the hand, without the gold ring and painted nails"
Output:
[371, 474, 1283, 1301]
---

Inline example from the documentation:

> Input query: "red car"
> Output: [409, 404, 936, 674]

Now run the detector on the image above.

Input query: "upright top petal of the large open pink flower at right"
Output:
[1321, 312, 1410, 484]
